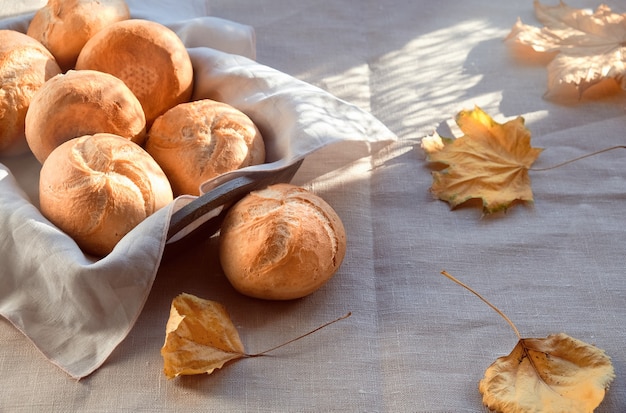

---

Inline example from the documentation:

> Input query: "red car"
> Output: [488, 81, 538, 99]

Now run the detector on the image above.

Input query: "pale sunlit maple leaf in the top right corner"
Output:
[506, 1, 626, 98]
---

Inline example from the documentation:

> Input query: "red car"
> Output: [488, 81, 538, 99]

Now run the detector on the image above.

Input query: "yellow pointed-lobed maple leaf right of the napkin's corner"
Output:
[421, 107, 542, 214]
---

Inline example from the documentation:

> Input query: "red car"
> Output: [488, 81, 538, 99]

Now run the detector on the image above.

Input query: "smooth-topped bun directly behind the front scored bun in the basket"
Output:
[25, 70, 146, 163]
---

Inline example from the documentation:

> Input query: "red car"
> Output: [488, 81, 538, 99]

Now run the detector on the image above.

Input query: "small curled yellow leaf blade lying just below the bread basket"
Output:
[161, 293, 245, 379]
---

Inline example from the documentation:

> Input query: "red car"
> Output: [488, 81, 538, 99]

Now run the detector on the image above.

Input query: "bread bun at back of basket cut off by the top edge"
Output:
[26, 0, 130, 71]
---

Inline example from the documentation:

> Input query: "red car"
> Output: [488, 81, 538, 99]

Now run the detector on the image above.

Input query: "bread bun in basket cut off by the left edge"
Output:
[0, 30, 61, 156]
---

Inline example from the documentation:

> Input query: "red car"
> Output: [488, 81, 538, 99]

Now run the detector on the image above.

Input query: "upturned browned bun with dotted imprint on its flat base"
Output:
[76, 19, 193, 126]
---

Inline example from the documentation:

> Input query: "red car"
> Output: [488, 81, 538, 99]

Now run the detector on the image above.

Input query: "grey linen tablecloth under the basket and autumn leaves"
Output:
[0, 0, 626, 412]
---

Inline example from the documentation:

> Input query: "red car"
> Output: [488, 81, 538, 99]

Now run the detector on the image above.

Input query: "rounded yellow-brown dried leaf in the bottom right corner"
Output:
[478, 333, 615, 413]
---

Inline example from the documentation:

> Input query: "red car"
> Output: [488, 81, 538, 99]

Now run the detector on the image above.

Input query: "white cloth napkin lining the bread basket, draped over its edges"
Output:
[0, 8, 395, 379]
